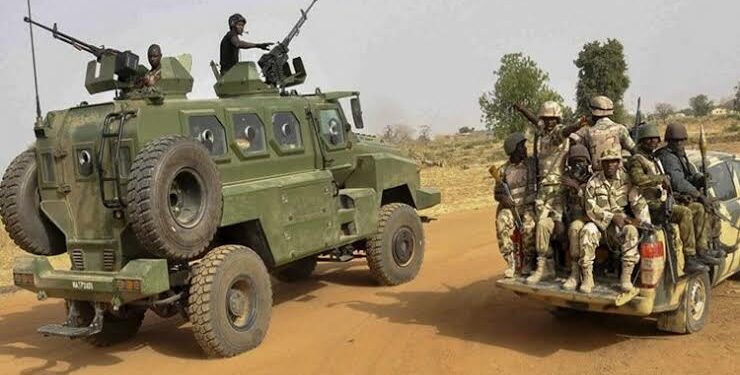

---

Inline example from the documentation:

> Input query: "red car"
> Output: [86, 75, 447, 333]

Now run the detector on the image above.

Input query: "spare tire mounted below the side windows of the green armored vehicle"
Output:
[127, 136, 223, 261]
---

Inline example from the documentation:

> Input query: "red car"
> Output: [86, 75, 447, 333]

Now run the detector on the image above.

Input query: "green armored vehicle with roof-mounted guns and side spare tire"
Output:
[0, 12, 440, 357]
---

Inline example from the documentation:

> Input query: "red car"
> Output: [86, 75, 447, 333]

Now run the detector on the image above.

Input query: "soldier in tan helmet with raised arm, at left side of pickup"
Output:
[527, 101, 581, 284]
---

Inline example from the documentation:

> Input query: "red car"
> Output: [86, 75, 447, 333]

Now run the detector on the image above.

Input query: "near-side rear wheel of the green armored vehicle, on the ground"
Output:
[188, 245, 272, 357]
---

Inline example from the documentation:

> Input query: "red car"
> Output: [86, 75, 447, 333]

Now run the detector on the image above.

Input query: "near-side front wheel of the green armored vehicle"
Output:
[367, 203, 424, 285]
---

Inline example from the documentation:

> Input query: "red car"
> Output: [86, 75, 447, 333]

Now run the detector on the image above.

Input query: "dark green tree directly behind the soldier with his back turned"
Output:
[573, 39, 630, 121]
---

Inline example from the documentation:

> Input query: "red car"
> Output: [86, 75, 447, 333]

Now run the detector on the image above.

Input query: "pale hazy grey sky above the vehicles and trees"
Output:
[0, 0, 740, 170]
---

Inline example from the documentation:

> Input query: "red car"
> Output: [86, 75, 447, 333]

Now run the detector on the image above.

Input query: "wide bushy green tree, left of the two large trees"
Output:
[478, 53, 563, 138]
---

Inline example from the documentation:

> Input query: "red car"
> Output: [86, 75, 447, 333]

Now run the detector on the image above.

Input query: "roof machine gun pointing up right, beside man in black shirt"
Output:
[257, 0, 318, 88]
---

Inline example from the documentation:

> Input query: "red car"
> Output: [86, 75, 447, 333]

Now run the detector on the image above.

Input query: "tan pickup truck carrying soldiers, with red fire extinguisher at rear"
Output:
[496, 151, 740, 333]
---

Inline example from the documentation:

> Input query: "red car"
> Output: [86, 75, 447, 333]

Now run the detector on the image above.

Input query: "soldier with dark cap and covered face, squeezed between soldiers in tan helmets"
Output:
[556, 145, 593, 290]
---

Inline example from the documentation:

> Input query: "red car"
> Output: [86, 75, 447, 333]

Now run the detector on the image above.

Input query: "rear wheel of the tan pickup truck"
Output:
[658, 272, 712, 333]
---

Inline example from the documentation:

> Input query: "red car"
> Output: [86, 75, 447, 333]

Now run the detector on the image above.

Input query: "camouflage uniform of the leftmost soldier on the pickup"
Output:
[494, 158, 535, 278]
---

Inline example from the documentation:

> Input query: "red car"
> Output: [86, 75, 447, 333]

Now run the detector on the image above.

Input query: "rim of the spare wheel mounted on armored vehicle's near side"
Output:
[167, 168, 205, 228]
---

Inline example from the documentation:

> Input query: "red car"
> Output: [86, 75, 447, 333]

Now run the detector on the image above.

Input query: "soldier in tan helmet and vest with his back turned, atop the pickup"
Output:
[573, 96, 635, 172]
